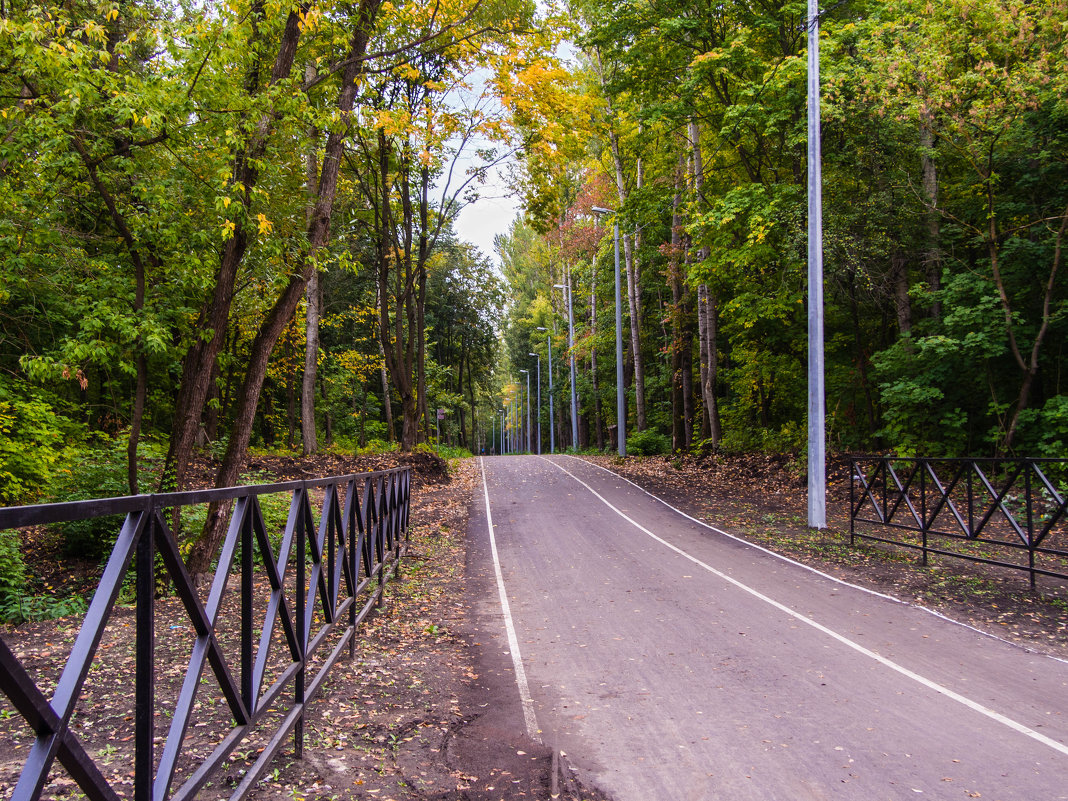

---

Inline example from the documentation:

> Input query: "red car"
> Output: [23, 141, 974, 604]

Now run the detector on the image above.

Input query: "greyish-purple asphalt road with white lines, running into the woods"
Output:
[468, 455, 1068, 801]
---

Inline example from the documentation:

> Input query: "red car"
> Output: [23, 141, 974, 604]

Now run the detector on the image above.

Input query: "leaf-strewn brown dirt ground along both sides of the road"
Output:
[0, 454, 1068, 801]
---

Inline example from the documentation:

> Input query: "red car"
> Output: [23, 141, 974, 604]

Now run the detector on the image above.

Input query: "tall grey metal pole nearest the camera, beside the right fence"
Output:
[806, 0, 827, 529]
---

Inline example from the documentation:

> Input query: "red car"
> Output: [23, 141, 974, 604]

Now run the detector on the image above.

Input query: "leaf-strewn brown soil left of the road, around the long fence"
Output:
[0, 453, 602, 801]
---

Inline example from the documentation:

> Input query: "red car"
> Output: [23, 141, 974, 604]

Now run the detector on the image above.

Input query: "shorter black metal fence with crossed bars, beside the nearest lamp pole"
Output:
[849, 456, 1068, 587]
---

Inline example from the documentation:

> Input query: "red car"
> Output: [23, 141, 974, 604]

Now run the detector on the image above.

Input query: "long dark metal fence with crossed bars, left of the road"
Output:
[0, 468, 411, 801]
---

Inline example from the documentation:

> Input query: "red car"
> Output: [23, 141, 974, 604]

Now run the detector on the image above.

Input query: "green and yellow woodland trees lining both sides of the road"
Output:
[0, 0, 1068, 529]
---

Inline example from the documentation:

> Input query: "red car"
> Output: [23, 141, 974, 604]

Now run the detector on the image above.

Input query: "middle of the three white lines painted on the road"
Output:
[538, 459, 1068, 756]
